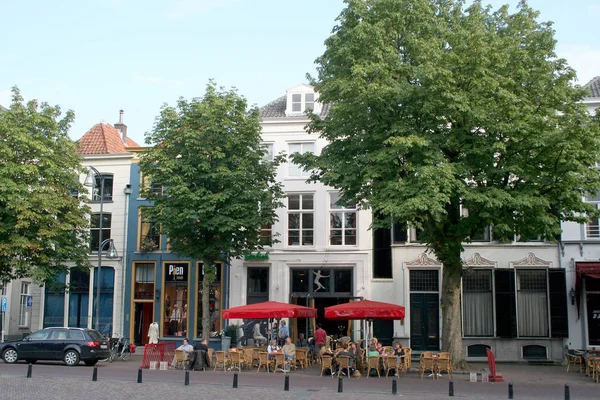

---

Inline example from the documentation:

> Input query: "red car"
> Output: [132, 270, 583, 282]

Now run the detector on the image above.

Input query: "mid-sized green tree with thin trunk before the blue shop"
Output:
[140, 82, 283, 338]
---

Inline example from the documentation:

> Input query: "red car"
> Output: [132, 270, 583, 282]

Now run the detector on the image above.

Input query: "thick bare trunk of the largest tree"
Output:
[441, 263, 467, 369]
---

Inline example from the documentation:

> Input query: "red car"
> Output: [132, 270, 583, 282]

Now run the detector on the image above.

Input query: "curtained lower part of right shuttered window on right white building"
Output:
[517, 291, 548, 336]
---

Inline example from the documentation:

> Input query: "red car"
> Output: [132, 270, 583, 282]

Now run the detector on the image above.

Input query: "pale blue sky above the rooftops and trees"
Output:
[0, 0, 600, 144]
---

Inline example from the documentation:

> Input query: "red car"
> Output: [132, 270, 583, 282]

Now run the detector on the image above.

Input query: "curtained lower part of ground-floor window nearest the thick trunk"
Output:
[463, 292, 494, 336]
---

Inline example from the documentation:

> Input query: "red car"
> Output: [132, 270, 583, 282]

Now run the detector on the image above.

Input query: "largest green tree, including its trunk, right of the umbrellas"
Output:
[294, 0, 600, 364]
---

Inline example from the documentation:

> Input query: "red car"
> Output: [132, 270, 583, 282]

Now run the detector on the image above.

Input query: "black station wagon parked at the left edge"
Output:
[0, 328, 110, 366]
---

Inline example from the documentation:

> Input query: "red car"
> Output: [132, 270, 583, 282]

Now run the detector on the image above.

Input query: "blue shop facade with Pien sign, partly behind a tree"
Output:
[124, 162, 229, 345]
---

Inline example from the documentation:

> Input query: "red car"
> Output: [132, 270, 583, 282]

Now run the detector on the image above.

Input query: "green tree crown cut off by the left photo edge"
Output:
[0, 88, 89, 282]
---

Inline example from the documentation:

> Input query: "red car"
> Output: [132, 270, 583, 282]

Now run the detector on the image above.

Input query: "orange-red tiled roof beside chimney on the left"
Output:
[77, 122, 139, 154]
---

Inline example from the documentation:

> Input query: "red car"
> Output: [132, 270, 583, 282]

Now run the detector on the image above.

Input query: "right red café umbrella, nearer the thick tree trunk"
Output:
[325, 300, 405, 320]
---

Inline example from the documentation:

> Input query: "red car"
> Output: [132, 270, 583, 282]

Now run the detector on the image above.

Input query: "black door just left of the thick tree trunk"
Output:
[410, 293, 440, 351]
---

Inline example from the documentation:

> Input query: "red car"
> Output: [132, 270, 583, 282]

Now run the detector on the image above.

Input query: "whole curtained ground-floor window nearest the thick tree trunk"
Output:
[462, 269, 494, 336]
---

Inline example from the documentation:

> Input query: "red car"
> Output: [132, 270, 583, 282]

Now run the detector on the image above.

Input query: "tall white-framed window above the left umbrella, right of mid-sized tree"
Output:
[288, 194, 314, 246]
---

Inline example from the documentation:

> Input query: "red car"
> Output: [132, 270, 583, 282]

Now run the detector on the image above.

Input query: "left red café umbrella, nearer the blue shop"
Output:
[223, 301, 317, 319]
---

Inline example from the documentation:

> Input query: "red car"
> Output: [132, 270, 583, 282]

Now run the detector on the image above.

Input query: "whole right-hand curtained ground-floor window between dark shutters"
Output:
[517, 269, 548, 337]
